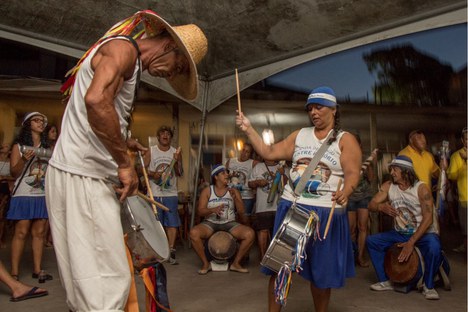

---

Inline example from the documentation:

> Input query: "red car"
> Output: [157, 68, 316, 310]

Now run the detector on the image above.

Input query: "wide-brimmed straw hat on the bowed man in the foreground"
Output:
[141, 10, 208, 101]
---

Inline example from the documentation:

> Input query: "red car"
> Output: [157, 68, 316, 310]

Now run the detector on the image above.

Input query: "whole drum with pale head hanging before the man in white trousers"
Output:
[121, 196, 170, 271]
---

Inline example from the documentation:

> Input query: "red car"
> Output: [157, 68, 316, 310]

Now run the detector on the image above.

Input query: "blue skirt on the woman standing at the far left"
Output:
[7, 196, 49, 220]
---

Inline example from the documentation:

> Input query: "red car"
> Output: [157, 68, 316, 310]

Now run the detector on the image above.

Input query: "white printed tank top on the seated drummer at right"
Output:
[388, 181, 437, 235]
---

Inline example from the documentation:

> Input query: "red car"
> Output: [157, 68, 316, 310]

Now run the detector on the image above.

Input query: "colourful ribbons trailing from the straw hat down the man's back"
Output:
[60, 10, 156, 97]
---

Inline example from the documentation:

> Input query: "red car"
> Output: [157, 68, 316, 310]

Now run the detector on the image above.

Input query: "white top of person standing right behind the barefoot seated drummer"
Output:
[228, 158, 254, 199]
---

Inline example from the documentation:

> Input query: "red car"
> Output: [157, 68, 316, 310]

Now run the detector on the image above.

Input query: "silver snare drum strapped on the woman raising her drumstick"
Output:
[261, 205, 318, 272]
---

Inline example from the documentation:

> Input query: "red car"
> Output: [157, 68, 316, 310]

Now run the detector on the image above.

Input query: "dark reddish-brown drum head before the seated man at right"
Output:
[384, 244, 419, 284]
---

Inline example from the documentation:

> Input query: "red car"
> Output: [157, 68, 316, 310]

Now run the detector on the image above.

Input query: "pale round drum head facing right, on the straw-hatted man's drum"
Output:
[122, 196, 170, 261]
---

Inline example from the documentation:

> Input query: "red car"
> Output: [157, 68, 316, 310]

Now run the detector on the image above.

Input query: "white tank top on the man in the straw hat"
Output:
[49, 37, 140, 179]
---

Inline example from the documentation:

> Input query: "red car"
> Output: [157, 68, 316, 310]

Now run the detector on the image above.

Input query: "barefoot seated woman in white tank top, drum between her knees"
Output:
[190, 165, 255, 275]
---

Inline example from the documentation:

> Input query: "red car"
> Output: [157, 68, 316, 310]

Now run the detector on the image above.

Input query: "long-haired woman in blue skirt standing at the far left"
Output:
[7, 112, 52, 283]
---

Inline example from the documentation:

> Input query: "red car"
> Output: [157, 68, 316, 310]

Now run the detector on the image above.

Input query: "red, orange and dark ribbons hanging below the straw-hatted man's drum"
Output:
[140, 263, 172, 312]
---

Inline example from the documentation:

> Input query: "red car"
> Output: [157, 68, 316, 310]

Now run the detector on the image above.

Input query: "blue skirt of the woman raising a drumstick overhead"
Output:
[262, 199, 356, 288]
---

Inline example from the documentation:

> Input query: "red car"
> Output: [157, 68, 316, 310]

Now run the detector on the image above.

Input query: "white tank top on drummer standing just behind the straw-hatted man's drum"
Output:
[148, 145, 177, 197]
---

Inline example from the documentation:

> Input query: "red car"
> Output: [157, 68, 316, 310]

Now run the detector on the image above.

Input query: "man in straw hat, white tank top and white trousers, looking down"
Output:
[46, 10, 207, 311]
